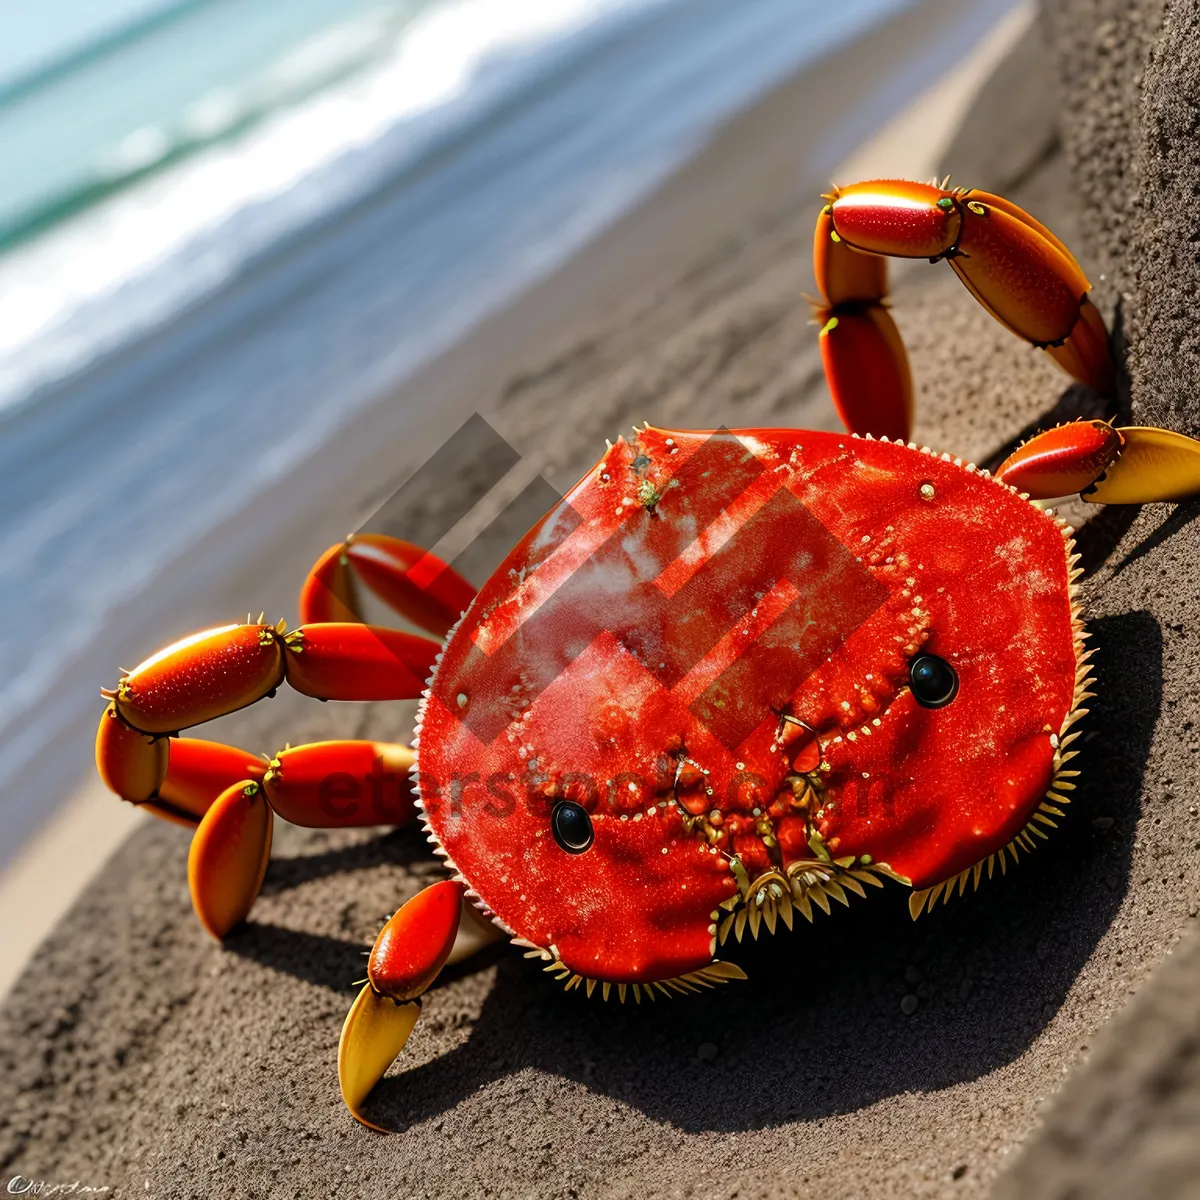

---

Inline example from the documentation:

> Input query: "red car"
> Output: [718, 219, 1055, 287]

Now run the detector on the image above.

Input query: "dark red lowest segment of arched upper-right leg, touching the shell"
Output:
[820, 304, 912, 442]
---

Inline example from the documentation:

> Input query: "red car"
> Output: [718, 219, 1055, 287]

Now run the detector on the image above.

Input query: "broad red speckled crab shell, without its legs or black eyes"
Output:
[418, 428, 1079, 982]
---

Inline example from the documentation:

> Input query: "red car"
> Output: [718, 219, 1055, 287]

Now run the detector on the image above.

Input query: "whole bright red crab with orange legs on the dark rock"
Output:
[96, 181, 1200, 1128]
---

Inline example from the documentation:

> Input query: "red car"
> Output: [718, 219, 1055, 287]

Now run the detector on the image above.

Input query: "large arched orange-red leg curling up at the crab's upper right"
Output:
[814, 180, 1112, 437]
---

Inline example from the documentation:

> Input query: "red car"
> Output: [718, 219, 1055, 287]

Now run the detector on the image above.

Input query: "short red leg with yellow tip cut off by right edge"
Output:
[996, 421, 1200, 504]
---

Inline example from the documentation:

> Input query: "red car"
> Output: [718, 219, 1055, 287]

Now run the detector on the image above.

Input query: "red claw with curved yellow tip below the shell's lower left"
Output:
[337, 880, 466, 1132]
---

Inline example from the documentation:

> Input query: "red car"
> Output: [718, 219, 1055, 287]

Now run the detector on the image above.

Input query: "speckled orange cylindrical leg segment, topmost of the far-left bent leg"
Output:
[106, 625, 283, 733]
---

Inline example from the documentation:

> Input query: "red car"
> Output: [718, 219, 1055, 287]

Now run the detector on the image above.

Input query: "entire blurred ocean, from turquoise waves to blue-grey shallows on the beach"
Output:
[0, 0, 1008, 858]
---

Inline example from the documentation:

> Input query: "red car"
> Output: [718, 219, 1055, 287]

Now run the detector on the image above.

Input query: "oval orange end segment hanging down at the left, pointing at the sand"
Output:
[187, 780, 272, 940]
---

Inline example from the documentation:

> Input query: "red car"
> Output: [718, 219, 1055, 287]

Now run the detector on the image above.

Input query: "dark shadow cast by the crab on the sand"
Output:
[227, 597, 1162, 1132]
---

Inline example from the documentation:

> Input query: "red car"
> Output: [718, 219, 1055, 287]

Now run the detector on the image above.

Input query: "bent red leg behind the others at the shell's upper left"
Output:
[300, 533, 475, 637]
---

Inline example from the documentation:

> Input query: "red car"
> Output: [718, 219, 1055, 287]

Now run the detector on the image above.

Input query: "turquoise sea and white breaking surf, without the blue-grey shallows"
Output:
[0, 0, 661, 409]
